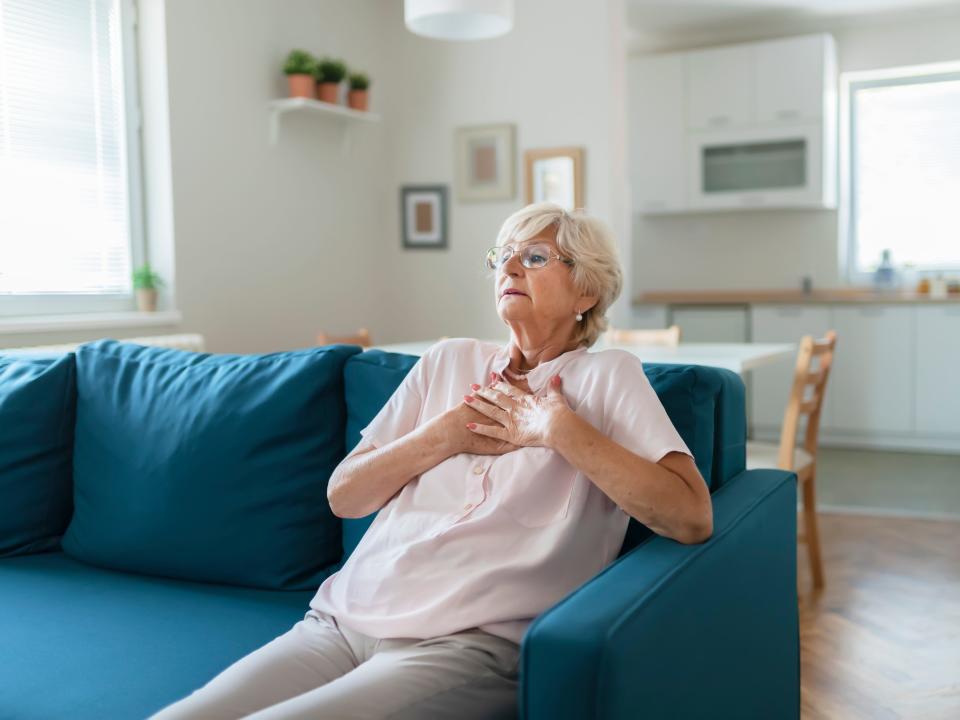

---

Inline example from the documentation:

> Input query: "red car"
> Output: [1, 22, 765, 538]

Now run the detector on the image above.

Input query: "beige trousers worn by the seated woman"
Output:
[149, 609, 520, 720]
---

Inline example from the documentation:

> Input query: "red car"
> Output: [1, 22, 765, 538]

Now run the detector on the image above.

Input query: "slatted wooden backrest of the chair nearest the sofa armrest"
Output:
[777, 330, 837, 470]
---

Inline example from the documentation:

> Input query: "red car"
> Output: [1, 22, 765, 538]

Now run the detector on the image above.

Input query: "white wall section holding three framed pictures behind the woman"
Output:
[379, 0, 629, 340]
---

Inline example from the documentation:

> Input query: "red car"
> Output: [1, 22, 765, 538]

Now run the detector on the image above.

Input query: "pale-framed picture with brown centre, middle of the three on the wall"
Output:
[454, 123, 516, 202]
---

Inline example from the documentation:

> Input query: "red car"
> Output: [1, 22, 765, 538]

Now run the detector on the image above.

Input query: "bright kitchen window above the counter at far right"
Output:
[841, 63, 960, 280]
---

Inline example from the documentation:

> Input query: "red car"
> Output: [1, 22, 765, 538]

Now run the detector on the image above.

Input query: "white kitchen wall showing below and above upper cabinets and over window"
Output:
[633, 13, 960, 294]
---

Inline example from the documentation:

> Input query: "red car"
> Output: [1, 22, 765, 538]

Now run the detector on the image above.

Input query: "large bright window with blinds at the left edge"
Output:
[0, 0, 143, 315]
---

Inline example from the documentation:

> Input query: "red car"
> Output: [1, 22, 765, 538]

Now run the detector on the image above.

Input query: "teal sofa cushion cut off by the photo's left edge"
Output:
[0, 353, 77, 557]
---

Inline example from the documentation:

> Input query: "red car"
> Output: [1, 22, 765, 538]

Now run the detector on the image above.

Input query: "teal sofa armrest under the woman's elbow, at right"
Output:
[519, 470, 800, 720]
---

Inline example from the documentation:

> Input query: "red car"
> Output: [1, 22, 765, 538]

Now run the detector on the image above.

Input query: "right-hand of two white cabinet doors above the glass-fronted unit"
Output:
[756, 35, 829, 123]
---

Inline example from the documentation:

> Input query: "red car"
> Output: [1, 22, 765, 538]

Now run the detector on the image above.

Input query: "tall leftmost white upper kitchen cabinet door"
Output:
[627, 53, 686, 213]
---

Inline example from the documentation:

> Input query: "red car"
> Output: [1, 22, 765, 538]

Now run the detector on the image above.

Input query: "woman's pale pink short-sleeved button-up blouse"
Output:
[310, 338, 691, 644]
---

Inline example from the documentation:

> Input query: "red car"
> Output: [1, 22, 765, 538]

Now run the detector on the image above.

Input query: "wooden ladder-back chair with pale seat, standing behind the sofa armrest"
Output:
[747, 330, 837, 589]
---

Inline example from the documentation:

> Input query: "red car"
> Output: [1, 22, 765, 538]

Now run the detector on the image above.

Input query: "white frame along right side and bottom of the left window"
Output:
[0, 0, 147, 318]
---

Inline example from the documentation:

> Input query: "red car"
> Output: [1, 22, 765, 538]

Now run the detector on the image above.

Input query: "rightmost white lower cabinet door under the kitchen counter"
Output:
[915, 305, 960, 436]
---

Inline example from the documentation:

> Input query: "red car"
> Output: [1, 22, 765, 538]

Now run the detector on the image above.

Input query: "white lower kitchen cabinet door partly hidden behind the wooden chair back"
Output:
[751, 305, 834, 437]
